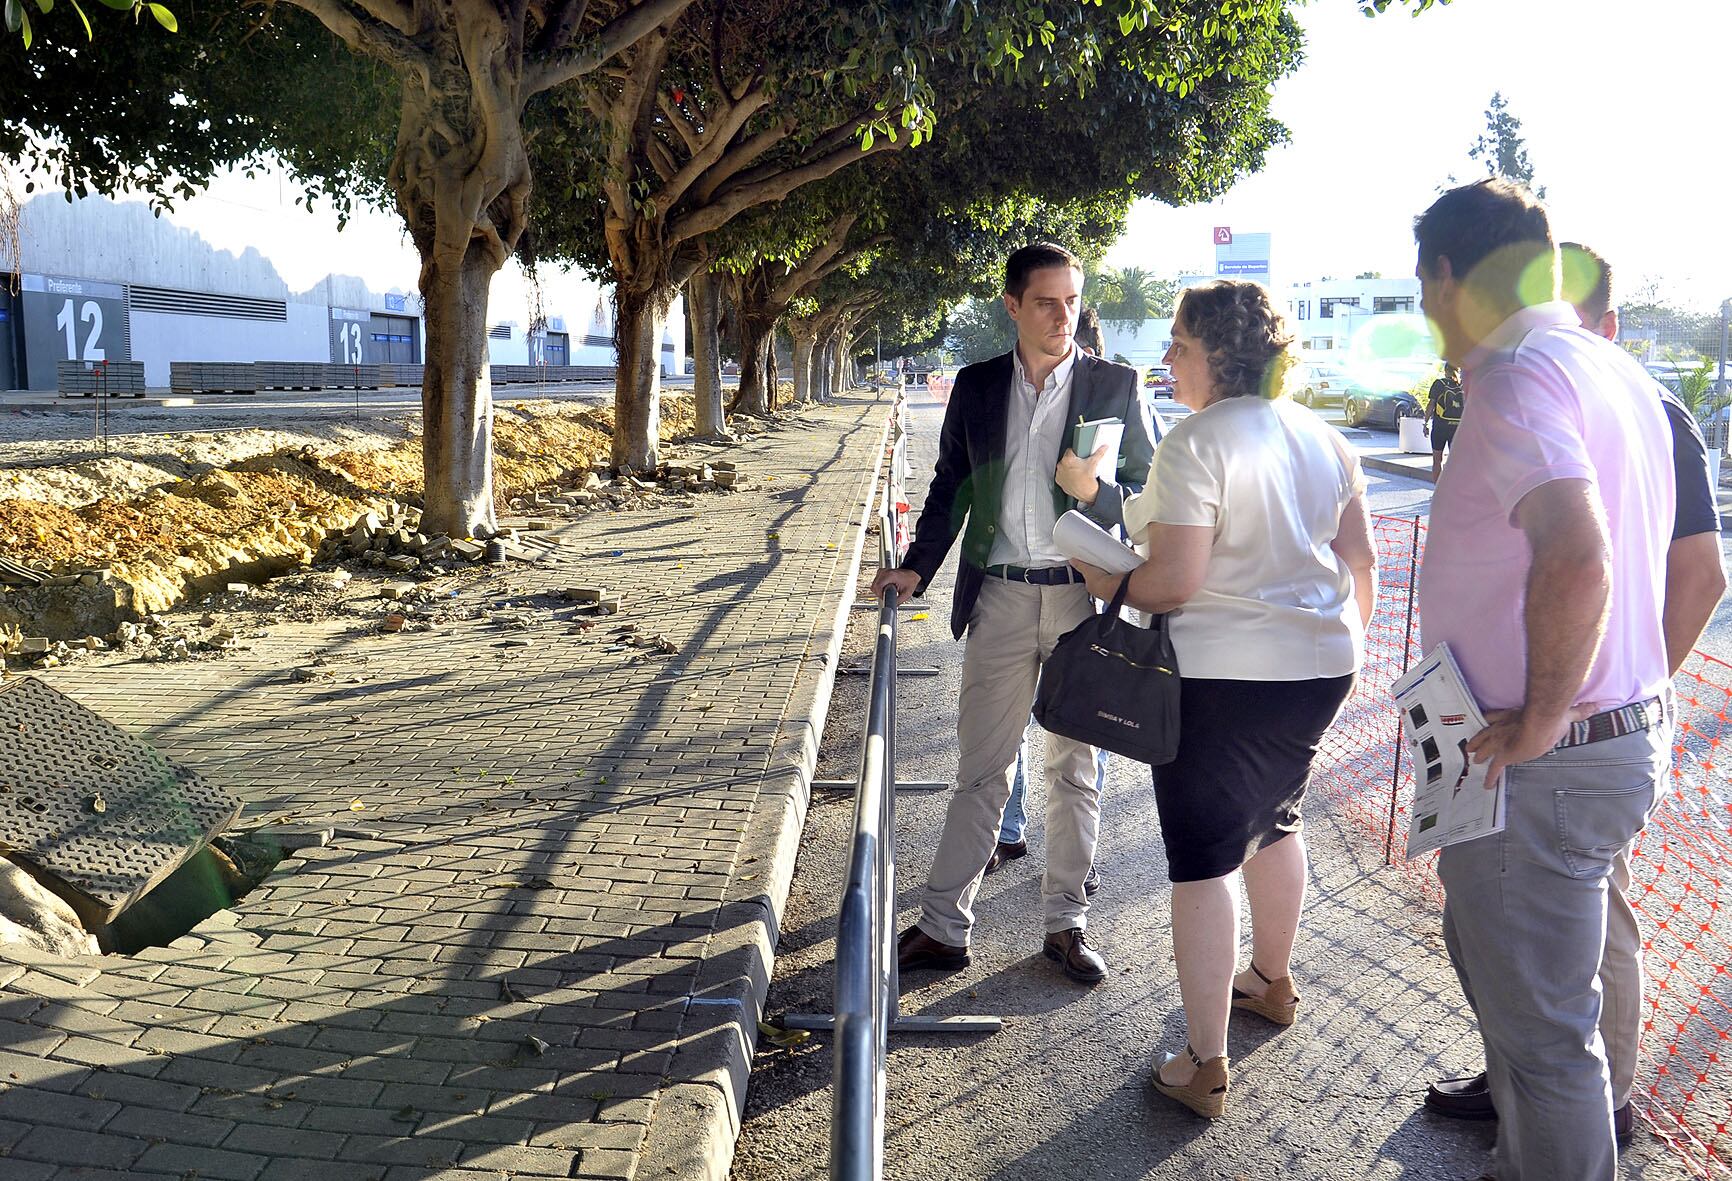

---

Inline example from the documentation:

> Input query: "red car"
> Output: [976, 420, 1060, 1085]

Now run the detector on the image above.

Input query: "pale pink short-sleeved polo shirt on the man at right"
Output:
[1419, 303, 1673, 710]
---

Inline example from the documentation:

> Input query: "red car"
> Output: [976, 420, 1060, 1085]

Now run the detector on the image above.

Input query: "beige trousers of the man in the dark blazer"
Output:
[920, 578, 1100, 947]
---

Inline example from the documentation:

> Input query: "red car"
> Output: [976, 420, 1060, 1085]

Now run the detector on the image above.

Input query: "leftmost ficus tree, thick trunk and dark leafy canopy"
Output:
[0, 0, 695, 537]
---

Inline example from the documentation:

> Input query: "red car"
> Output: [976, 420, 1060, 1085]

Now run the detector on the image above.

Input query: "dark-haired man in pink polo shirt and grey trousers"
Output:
[1413, 180, 1673, 1181]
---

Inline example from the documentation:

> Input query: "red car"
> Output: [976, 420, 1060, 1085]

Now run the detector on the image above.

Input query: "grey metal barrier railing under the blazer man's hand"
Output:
[783, 398, 1003, 1181]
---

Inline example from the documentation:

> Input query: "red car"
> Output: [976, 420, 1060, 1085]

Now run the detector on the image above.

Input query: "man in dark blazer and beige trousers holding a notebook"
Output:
[873, 242, 1157, 984]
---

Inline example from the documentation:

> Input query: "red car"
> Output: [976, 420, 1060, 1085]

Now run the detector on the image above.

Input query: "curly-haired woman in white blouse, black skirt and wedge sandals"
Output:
[1083, 279, 1377, 1119]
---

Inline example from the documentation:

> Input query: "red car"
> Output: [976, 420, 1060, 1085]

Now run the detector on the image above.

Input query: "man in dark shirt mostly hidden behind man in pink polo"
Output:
[1425, 242, 1727, 1145]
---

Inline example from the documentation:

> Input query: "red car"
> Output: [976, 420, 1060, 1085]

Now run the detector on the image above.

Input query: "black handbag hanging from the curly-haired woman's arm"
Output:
[1034, 575, 1179, 767]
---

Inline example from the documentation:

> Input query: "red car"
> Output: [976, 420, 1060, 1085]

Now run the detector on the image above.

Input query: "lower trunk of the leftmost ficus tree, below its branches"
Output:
[421, 248, 499, 537]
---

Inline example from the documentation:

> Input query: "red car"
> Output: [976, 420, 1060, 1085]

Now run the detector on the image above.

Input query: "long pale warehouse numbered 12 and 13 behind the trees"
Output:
[0, 192, 686, 390]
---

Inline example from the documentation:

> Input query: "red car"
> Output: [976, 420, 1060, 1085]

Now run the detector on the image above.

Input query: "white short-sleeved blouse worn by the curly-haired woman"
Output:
[1124, 397, 1365, 681]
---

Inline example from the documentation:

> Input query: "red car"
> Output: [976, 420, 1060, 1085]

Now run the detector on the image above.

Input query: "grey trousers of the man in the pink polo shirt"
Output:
[1438, 726, 1671, 1181]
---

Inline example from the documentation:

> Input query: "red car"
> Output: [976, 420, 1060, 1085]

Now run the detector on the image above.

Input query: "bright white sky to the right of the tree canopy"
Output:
[1107, 0, 1732, 308]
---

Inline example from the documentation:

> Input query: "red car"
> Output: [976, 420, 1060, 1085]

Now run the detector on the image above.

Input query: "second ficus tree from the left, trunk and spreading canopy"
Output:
[519, 0, 1330, 468]
